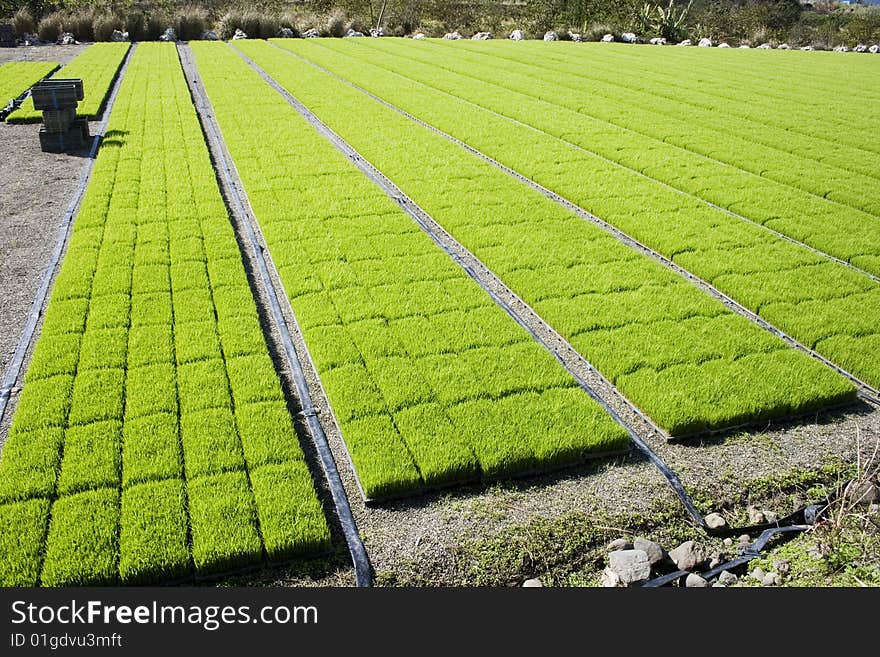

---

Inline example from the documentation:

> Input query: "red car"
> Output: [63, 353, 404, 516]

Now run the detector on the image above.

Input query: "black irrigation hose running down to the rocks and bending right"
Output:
[242, 49, 860, 588]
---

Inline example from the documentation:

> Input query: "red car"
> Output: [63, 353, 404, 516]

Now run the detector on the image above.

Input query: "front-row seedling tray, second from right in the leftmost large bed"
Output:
[187, 471, 262, 575]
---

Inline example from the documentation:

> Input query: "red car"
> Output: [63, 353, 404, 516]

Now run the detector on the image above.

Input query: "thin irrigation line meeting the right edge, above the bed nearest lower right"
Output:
[272, 43, 880, 406]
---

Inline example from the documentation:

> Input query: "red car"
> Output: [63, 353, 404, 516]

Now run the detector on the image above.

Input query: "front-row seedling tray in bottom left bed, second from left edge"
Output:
[40, 488, 119, 586]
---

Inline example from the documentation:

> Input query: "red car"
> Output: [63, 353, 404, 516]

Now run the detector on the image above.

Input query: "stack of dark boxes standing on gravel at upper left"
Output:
[31, 79, 91, 153]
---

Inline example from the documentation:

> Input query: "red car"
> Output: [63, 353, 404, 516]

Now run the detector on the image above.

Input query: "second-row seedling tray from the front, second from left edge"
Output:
[58, 421, 122, 495]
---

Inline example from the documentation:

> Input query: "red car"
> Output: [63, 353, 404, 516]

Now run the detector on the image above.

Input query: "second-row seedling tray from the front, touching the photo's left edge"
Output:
[0, 427, 64, 502]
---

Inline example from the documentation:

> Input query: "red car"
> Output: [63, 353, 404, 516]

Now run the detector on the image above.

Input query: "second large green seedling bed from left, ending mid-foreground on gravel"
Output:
[193, 44, 627, 499]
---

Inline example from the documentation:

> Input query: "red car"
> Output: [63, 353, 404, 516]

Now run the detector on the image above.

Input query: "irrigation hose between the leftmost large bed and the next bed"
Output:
[178, 46, 372, 587]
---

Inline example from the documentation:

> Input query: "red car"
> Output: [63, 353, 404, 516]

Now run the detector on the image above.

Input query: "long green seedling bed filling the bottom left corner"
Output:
[0, 44, 328, 586]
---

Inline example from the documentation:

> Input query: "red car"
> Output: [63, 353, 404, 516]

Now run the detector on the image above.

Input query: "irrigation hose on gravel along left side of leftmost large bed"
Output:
[0, 44, 137, 422]
